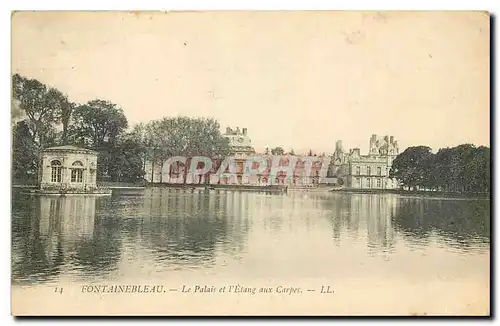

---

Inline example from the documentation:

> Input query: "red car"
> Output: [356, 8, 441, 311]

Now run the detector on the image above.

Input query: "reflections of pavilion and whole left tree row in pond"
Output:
[12, 189, 251, 282]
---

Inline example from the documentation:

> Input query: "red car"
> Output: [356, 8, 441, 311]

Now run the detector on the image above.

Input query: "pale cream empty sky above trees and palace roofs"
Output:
[12, 12, 490, 153]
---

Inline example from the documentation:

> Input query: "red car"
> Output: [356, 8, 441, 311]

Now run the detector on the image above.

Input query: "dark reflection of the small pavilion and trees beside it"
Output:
[12, 196, 112, 282]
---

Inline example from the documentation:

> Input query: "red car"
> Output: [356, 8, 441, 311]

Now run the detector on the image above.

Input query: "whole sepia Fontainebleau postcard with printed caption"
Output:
[10, 11, 491, 316]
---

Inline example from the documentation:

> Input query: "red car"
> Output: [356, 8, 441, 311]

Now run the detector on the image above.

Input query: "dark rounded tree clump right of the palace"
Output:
[390, 144, 491, 193]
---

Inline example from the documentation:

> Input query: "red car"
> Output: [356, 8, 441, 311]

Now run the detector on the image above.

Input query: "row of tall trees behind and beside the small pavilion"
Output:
[12, 74, 229, 182]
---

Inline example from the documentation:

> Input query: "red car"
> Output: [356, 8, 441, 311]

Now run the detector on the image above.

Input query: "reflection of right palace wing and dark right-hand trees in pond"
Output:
[310, 194, 490, 257]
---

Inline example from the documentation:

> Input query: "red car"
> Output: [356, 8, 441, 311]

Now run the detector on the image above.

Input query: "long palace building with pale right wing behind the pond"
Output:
[145, 127, 399, 189]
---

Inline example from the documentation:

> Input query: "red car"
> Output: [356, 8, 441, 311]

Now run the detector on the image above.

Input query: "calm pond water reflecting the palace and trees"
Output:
[12, 188, 490, 314]
